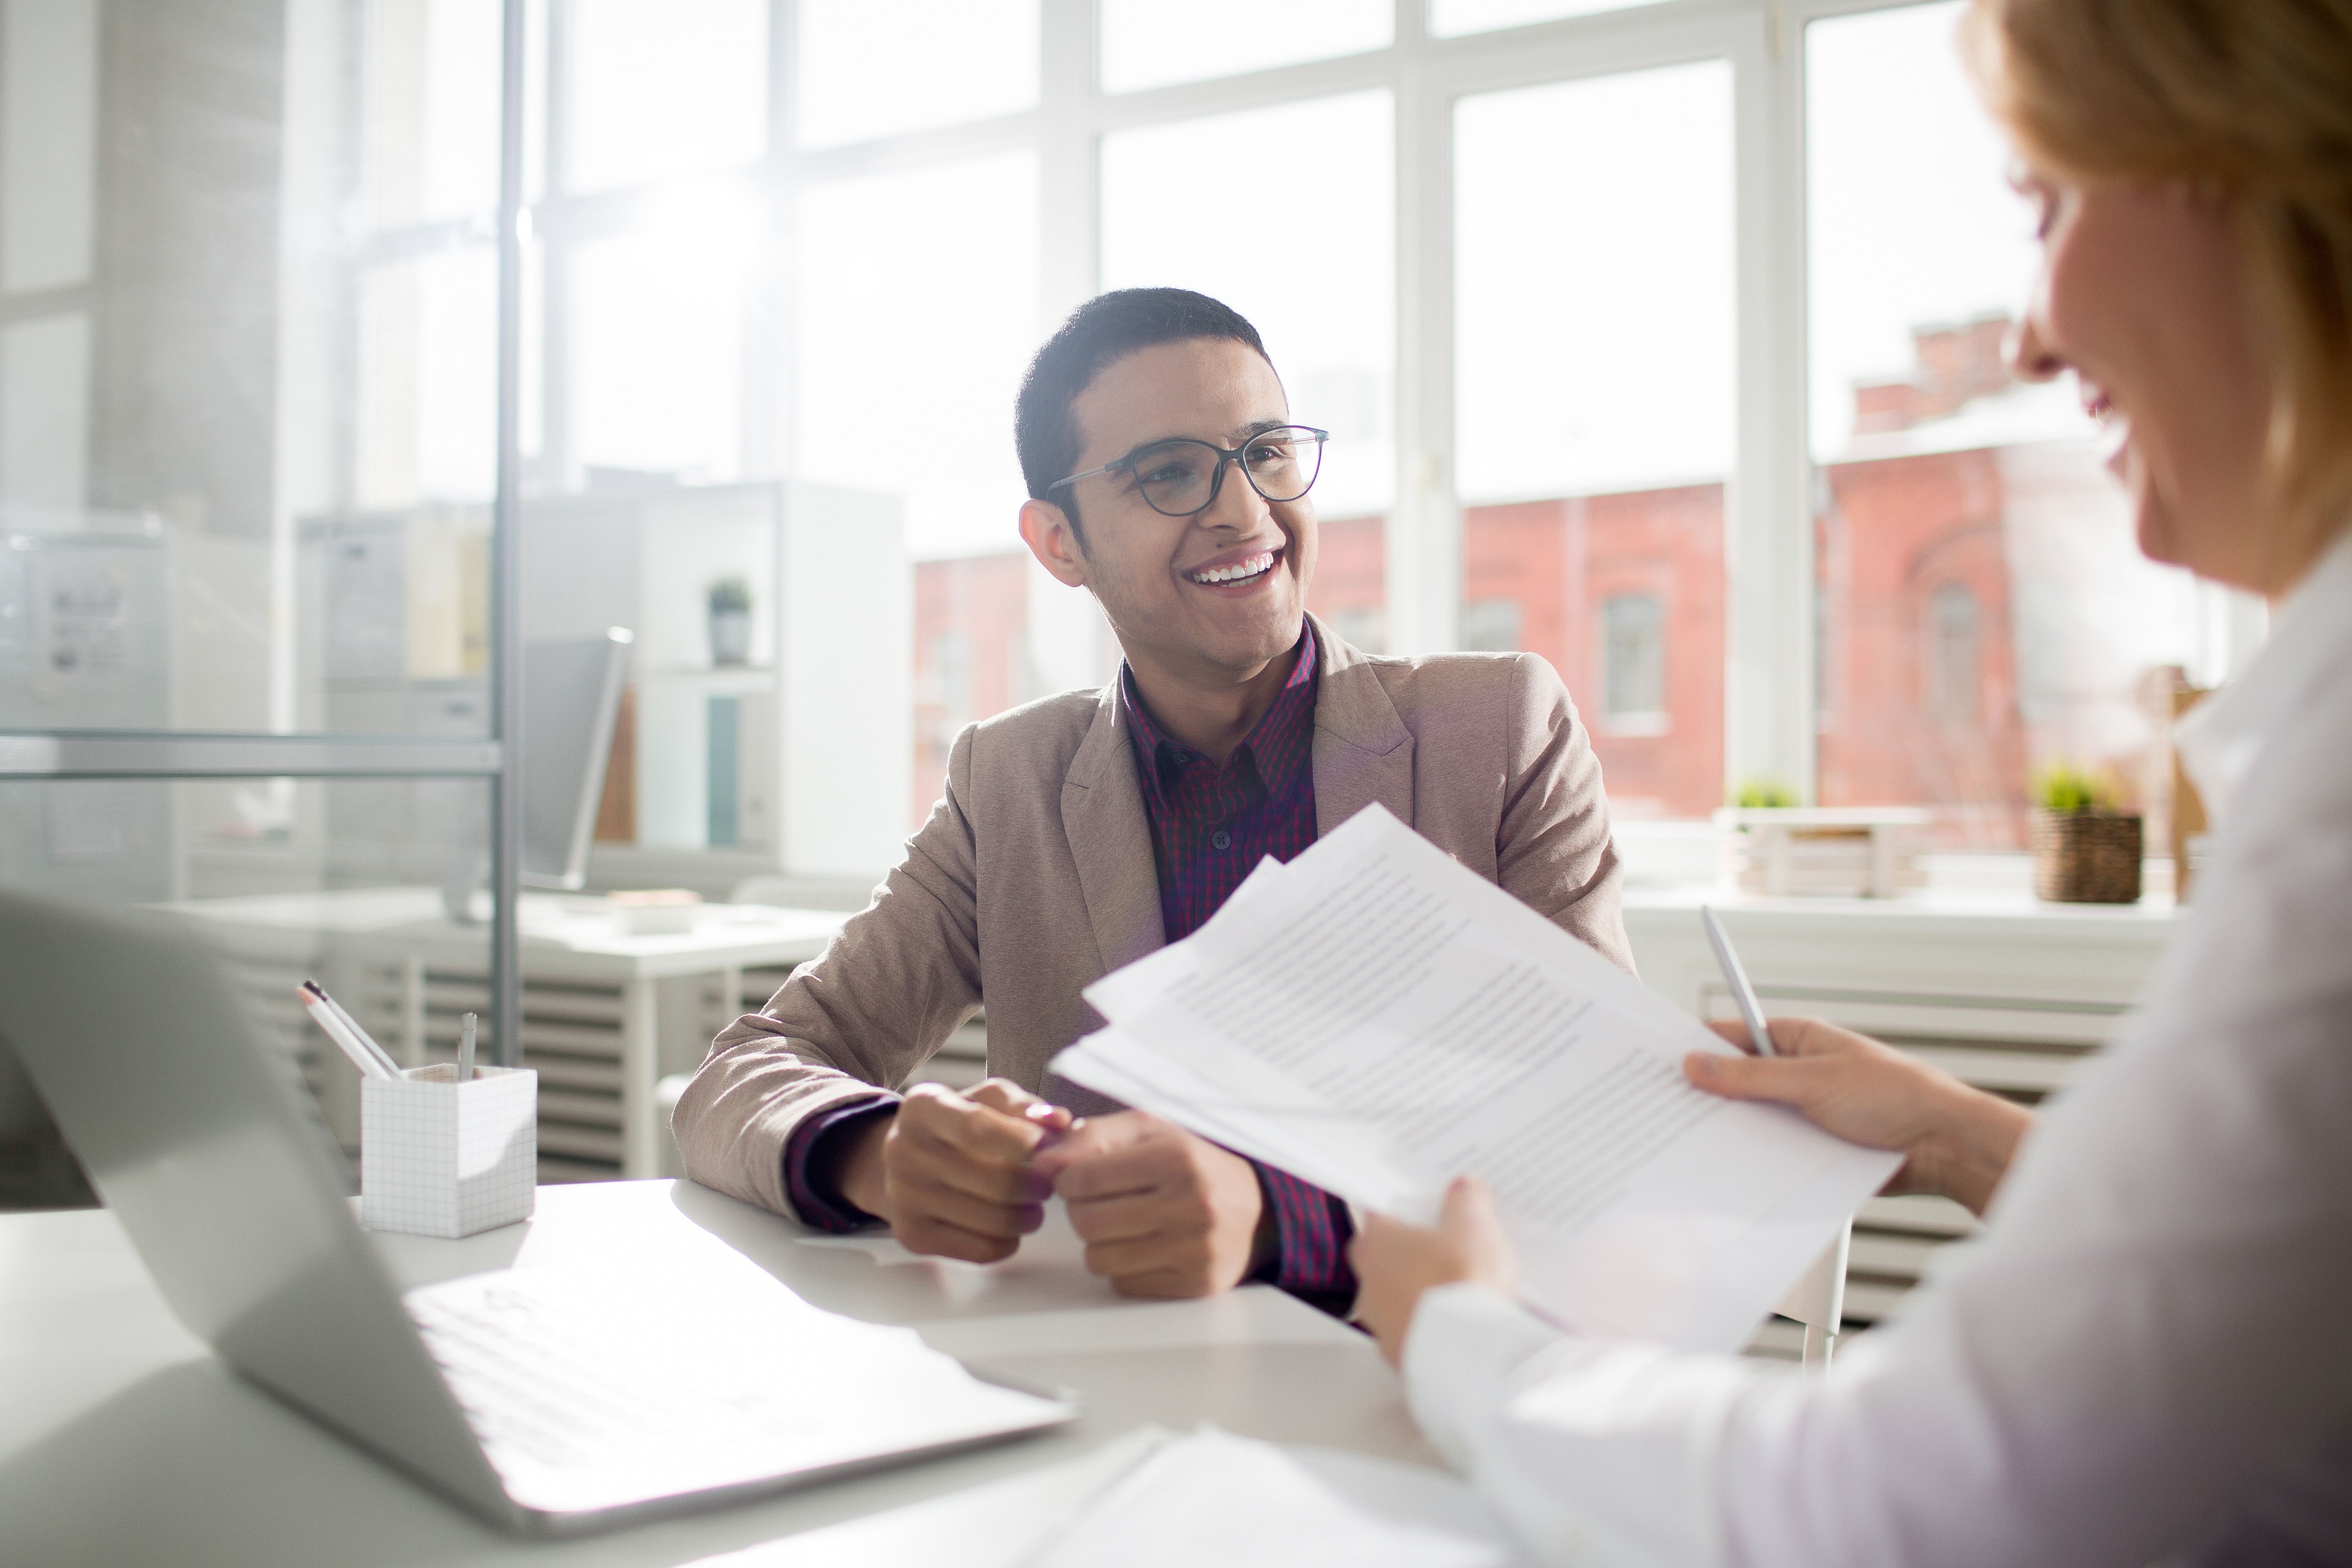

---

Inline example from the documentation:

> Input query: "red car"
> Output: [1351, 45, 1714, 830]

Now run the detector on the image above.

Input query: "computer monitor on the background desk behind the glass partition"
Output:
[522, 625, 635, 889]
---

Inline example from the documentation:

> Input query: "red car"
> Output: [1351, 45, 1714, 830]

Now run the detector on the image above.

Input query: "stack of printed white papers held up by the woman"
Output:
[1054, 806, 1900, 1350]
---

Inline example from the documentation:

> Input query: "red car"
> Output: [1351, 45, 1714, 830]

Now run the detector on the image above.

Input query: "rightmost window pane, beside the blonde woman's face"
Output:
[1806, 5, 2227, 849]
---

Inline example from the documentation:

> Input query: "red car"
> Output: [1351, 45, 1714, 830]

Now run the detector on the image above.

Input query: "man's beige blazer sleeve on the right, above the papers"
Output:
[1494, 653, 1632, 973]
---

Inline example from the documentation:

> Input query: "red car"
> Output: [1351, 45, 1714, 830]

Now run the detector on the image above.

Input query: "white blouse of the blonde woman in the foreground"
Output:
[1404, 536, 2352, 1568]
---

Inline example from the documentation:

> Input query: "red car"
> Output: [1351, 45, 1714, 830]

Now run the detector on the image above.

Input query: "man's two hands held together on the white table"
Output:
[830, 1079, 1275, 1298]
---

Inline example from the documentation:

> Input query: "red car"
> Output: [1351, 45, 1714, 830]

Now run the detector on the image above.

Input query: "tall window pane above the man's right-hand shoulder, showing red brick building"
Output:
[1454, 61, 1736, 816]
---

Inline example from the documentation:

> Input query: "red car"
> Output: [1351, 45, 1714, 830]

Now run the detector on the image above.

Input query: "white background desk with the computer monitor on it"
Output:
[165, 886, 849, 1178]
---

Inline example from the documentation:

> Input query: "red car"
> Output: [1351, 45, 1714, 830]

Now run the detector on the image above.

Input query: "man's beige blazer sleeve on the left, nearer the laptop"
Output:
[670, 729, 981, 1218]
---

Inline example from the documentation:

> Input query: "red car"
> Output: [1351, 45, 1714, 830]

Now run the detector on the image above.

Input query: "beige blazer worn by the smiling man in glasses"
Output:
[673, 621, 1632, 1213]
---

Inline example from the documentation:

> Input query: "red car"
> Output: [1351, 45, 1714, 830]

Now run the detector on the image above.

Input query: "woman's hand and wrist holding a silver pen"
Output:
[1682, 1018, 2034, 1215]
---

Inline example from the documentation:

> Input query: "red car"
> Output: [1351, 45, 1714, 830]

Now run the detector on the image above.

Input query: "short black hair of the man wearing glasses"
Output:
[1014, 278, 1265, 531]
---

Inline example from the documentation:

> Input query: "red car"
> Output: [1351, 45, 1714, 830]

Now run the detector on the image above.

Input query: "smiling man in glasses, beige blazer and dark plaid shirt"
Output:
[675, 289, 1630, 1312]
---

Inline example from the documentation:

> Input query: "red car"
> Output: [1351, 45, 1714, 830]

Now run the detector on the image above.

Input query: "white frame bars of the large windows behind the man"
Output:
[350, 0, 2060, 846]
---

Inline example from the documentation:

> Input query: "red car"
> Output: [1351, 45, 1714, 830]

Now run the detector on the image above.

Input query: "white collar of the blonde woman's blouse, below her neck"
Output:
[2173, 529, 2352, 825]
